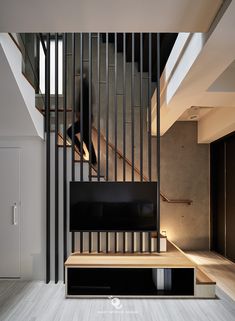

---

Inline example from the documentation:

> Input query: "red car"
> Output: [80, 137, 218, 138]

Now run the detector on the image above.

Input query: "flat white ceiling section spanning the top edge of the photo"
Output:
[0, 0, 223, 32]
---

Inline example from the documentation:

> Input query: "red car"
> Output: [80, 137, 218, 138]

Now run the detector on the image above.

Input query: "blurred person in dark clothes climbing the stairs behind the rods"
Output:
[67, 73, 97, 165]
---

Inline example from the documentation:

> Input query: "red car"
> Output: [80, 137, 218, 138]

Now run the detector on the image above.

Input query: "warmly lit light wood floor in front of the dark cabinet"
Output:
[187, 251, 235, 301]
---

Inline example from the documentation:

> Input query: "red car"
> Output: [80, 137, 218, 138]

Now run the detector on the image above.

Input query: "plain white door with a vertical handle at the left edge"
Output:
[0, 148, 20, 278]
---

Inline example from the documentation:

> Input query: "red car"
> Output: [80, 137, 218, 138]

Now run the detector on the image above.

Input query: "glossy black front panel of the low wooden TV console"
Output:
[66, 268, 194, 296]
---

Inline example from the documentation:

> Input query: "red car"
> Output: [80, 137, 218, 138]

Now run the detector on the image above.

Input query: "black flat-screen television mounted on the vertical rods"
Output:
[70, 182, 157, 232]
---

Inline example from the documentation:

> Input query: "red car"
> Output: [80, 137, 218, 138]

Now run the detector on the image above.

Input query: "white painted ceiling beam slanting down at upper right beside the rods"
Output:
[152, 1, 235, 141]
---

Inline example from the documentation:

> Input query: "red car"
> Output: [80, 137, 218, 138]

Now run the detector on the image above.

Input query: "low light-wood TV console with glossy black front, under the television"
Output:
[65, 241, 215, 298]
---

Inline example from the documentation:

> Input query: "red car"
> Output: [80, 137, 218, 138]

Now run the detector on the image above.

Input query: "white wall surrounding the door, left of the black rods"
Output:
[0, 137, 46, 280]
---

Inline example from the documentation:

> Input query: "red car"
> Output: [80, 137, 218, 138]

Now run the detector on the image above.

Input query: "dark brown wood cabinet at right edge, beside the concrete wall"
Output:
[211, 133, 235, 262]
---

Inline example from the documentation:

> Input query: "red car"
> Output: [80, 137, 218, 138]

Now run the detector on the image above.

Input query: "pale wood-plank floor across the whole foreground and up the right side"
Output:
[0, 252, 235, 321]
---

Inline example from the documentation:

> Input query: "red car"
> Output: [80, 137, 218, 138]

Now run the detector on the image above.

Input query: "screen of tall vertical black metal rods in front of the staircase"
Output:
[44, 33, 160, 282]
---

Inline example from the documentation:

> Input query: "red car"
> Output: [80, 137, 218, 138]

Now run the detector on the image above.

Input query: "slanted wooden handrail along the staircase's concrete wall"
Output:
[92, 127, 193, 205]
